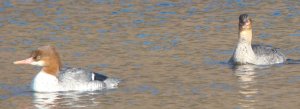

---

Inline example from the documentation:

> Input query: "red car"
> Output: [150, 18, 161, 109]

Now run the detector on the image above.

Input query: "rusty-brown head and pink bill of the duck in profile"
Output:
[14, 46, 61, 76]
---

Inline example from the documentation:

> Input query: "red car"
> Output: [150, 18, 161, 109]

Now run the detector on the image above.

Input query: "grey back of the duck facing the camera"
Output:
[252, 45, 286, 65]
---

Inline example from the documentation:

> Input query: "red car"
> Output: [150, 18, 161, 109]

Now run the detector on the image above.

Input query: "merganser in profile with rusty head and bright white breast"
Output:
[14, 46, 120, 92]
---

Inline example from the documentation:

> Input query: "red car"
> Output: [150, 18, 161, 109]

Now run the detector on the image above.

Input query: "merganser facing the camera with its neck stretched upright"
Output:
[229, 14, 286, 65]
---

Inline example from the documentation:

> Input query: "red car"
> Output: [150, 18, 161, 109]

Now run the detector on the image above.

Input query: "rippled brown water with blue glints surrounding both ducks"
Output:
[0, 0, 300, 109]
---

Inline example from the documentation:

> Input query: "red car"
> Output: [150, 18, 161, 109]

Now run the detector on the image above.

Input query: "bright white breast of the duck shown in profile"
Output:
[31, 70, 60, 92]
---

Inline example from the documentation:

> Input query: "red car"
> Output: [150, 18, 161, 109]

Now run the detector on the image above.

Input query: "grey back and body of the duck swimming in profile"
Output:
[58, 67, 119, 91]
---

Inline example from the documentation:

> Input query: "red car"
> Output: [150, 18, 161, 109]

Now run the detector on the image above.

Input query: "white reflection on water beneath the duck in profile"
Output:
[33, 91, 105, 109]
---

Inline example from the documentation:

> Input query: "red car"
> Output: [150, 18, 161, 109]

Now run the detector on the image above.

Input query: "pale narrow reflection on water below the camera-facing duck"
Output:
[234, 65, 268, 109]
